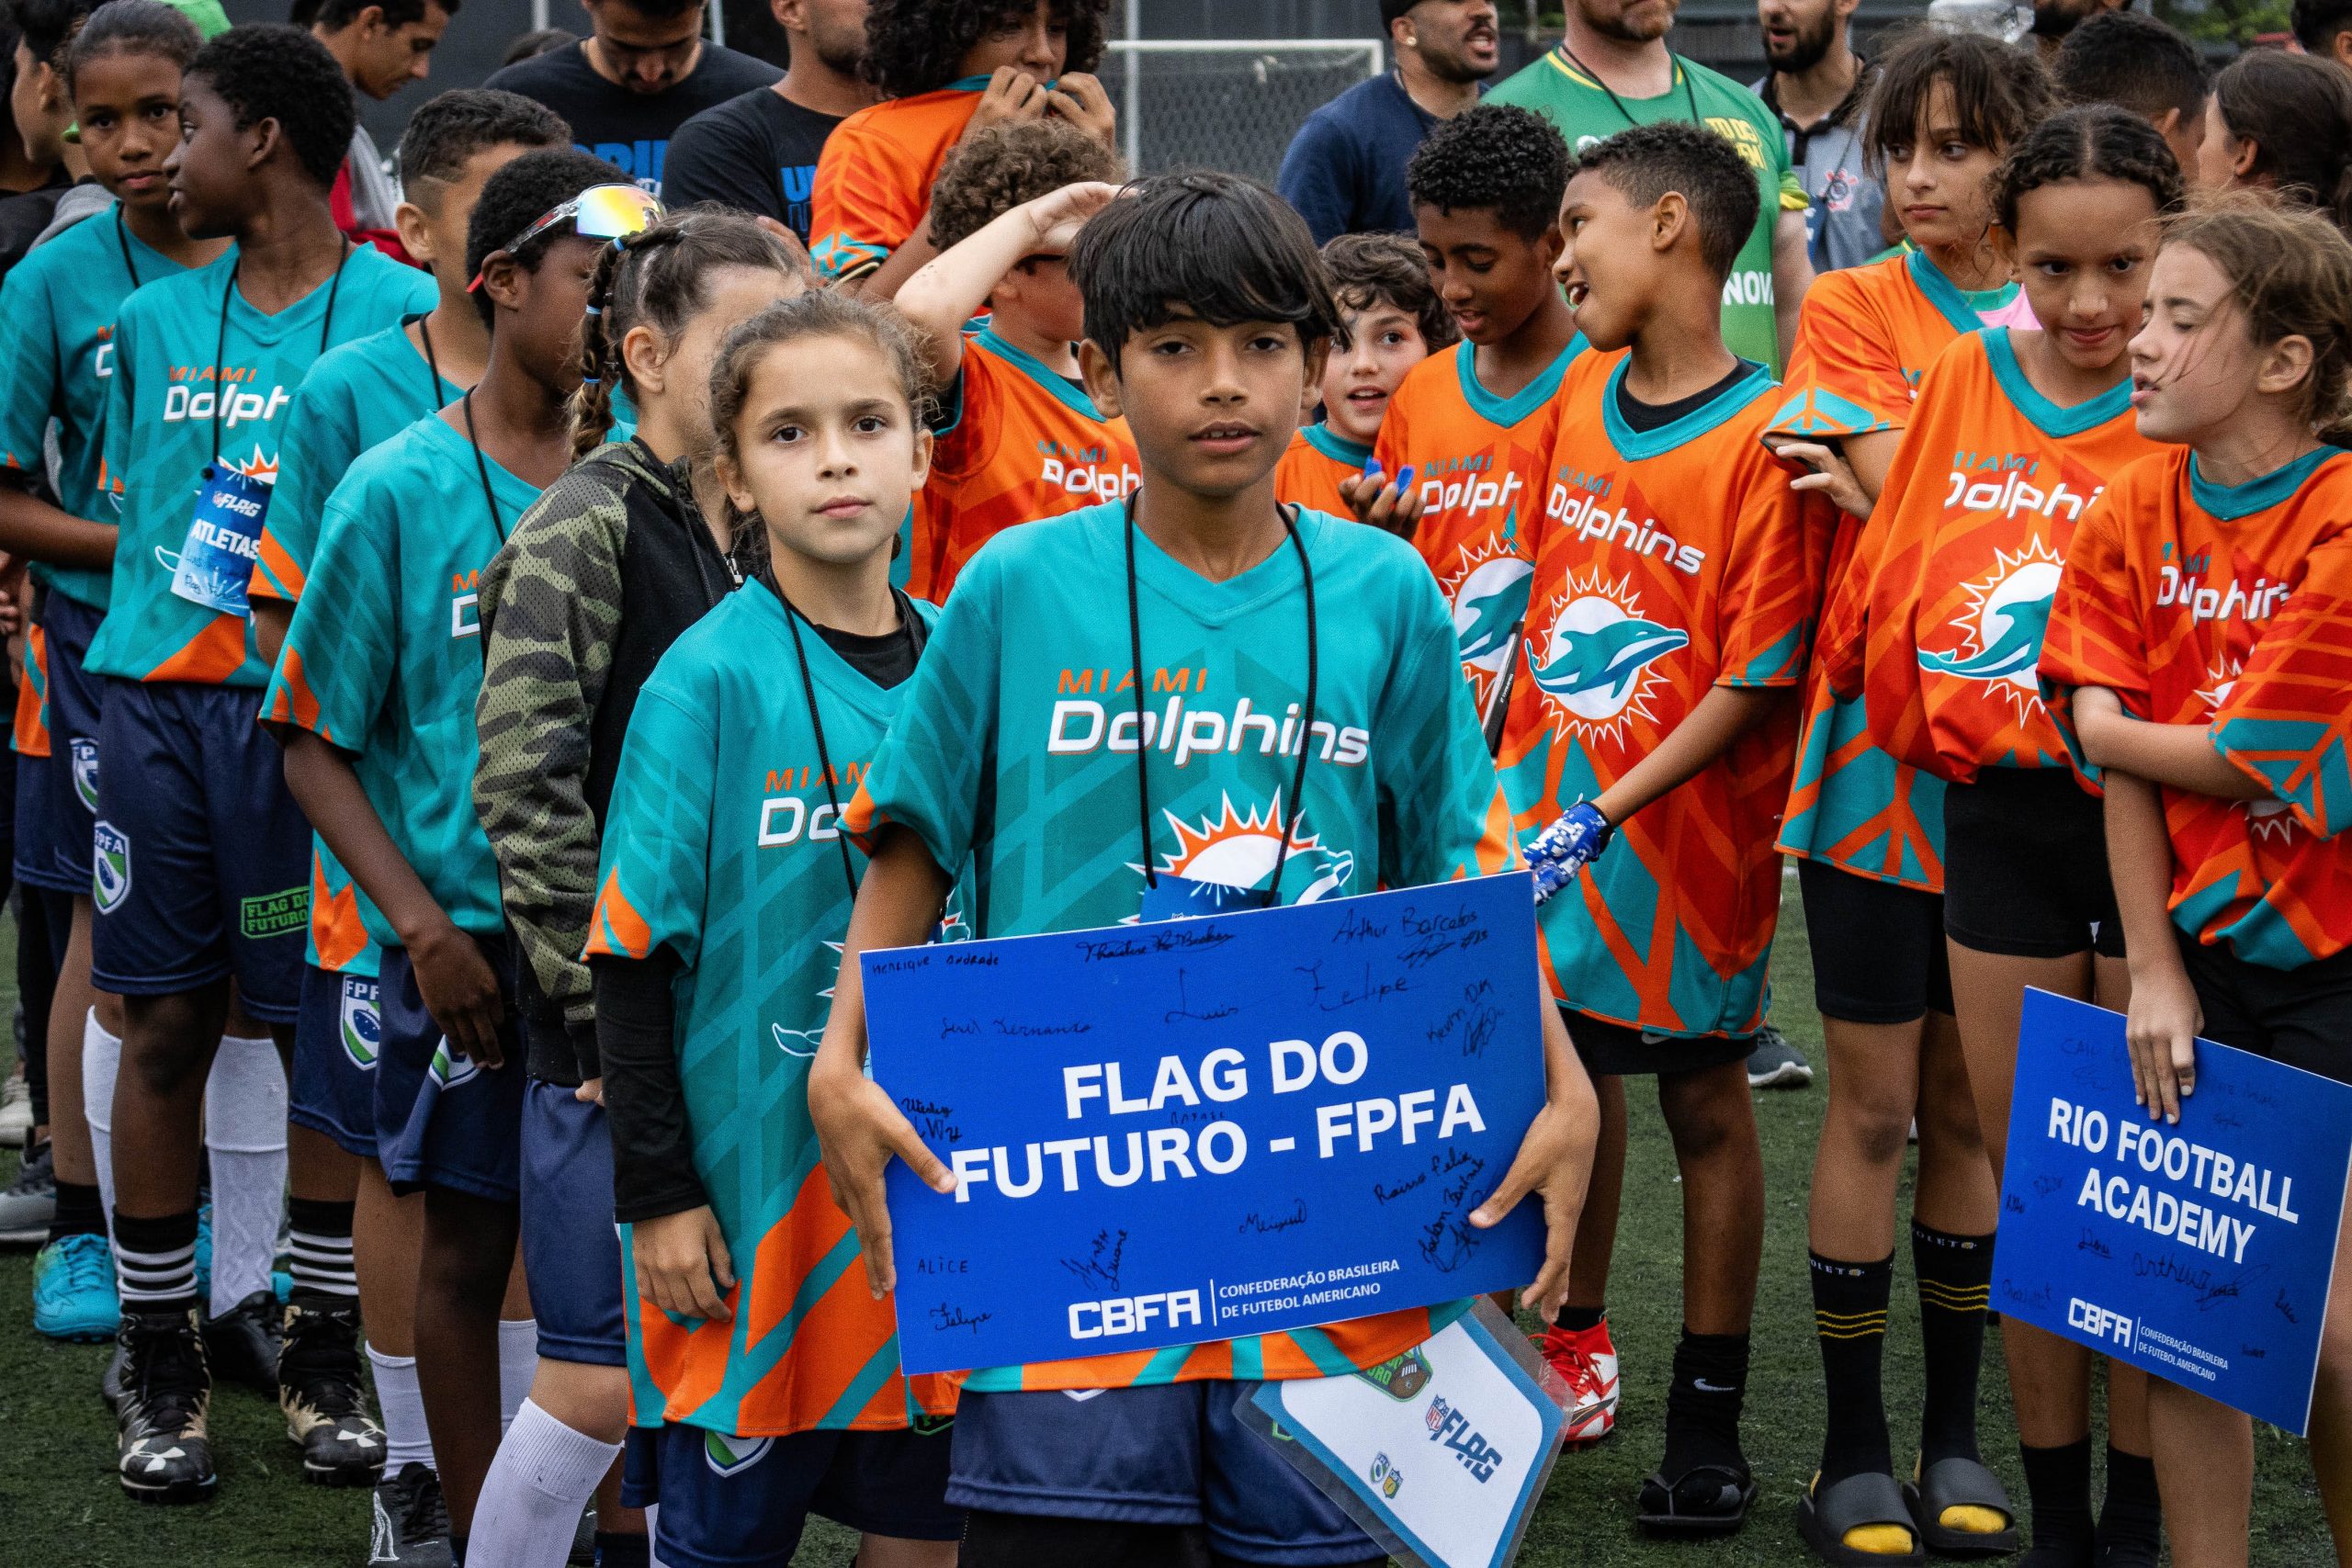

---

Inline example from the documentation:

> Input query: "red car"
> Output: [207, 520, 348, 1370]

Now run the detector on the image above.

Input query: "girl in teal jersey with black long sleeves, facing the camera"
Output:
[588, 291, 969, 1568]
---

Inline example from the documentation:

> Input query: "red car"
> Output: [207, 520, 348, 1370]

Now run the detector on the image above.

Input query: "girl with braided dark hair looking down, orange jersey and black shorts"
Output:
[1802, 106, 2180, 1568]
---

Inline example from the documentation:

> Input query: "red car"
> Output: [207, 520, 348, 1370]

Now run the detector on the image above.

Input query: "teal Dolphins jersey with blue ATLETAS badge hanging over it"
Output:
[89, 244, 435, 686]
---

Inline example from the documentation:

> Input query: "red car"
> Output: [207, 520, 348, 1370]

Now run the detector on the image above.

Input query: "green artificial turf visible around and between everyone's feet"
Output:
[0, 882, 2334, 1568]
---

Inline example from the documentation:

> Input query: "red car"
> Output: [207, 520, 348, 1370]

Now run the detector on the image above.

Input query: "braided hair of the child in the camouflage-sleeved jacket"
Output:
[571, 205, 816, 456]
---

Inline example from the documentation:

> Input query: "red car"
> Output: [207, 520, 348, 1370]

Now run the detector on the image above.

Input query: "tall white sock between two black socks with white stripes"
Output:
[205, 1034, 287, 1316]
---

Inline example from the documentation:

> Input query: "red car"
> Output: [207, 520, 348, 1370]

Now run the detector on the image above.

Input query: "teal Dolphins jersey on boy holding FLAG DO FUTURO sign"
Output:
[849, 505, 1515, 1392]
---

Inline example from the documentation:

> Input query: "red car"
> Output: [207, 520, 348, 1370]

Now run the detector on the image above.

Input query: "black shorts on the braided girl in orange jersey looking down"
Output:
[1943, 769, 2124, 959]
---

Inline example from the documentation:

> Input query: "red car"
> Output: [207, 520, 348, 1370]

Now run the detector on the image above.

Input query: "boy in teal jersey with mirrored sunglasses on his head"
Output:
[261, 146, 651, 1547]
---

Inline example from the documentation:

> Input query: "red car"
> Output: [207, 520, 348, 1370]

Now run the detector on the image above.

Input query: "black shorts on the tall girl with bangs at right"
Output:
[1797, 861, 1952, 1022]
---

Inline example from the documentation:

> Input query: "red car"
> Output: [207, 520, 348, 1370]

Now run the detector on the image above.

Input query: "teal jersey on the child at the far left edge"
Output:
[0, 209, 188, 609]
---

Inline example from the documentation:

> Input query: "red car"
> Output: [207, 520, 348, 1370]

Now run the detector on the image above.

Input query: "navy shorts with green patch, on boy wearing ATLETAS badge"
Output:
[89, 680, 311, 1022]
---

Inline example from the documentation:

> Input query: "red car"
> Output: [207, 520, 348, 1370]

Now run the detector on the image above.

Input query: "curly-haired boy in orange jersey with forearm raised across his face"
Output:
[896, 118, 1138, 604]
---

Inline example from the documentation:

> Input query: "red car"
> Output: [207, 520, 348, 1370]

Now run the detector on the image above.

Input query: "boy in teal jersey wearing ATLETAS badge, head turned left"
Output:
[89, 15, 433, 1500]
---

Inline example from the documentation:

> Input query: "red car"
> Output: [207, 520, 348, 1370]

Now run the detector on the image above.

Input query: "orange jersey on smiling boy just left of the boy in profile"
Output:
[1374, 336, 1585, 717]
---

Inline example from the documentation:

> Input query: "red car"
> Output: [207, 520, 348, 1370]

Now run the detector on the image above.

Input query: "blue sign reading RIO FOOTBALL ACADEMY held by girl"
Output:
[1992, 989, 2352, 1434]
